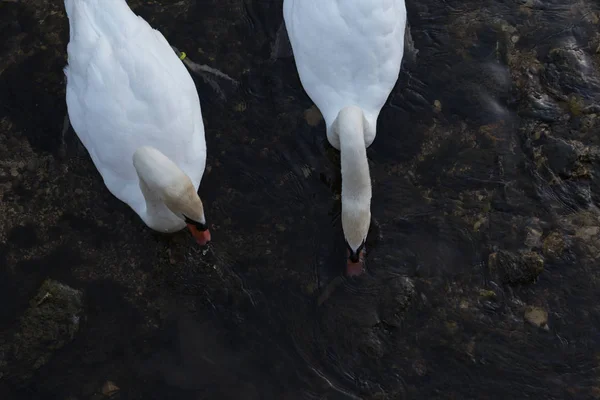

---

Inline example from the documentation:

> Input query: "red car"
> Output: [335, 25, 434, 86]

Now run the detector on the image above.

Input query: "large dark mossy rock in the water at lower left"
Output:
[0, 279, 83, 384]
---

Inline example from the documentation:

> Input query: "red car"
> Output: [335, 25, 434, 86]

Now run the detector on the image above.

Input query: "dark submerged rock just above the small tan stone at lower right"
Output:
[488, 250, 544, 284]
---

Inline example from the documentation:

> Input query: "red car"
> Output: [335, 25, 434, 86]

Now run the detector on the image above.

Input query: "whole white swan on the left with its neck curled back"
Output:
[65, 0, 210, 245]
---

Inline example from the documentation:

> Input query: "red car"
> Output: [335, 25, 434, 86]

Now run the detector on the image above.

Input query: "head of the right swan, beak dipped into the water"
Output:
[342, 199, 371, 276]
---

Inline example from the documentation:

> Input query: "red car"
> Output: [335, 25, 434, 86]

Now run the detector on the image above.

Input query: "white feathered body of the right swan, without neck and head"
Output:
[284, 0, 406, 149]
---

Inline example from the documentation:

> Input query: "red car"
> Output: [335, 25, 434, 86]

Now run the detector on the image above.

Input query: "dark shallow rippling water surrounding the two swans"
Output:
[0, 0, 600, 400]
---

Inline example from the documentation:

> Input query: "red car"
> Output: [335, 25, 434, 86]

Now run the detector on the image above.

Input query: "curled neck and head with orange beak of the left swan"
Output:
[133, 146, 211, 246]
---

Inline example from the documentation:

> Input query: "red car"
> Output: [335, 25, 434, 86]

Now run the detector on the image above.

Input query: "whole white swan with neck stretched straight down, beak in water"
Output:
[283, 0, 406, 275]
